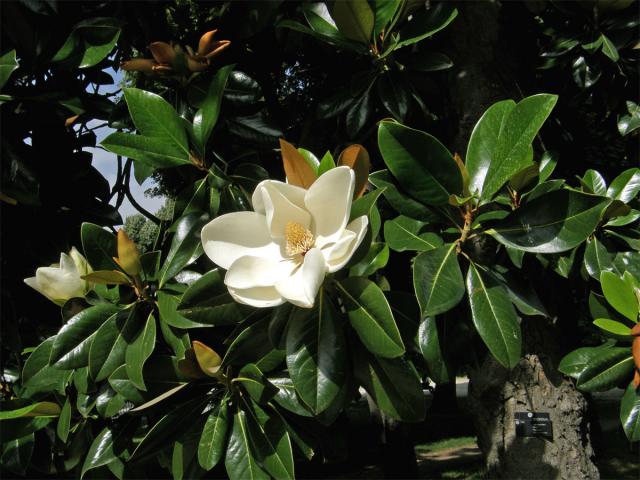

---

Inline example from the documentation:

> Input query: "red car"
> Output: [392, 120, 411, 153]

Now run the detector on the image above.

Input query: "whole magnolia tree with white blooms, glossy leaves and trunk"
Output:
[0, 1, 640, 479]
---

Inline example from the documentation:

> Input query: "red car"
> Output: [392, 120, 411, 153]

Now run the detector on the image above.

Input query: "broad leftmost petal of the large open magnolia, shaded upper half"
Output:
[201, 212, 281, 270]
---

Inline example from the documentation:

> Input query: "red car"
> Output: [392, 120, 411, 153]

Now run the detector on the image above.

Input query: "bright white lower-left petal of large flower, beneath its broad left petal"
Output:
[224, 255, 295, 289]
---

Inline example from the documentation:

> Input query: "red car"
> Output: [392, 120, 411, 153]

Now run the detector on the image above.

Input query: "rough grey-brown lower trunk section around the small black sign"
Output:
[469, 318, 600, 480]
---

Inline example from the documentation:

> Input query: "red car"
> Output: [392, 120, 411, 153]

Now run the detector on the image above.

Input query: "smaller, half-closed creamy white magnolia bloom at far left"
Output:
[24, 247, 91, 305]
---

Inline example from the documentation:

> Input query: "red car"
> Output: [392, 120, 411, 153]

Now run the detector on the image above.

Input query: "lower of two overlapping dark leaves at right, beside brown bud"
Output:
[576, 347, 634, 392]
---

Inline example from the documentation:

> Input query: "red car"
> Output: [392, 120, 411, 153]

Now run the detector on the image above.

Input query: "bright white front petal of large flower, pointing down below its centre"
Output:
[276, 248, 327, 308]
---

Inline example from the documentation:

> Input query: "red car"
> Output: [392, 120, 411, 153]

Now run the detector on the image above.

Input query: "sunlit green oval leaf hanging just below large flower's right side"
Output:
[336, 277, 405, 358]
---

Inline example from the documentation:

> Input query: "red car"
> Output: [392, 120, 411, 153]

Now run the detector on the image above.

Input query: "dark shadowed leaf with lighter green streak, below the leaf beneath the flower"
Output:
[355, 352, 426, 422]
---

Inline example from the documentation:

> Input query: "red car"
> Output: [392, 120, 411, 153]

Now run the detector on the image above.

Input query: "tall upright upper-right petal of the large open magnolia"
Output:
[304, 166, 355, 246]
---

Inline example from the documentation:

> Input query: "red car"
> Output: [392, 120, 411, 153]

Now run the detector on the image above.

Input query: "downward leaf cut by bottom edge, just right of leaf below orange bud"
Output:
[224, 410, 270, 480]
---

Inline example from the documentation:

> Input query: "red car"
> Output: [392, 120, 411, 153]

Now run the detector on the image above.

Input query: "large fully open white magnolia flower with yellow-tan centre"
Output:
[202, 167, 368, 308]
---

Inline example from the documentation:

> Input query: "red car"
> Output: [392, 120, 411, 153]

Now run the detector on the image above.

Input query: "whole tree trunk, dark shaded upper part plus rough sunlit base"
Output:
[444, 1, 599, 479]
